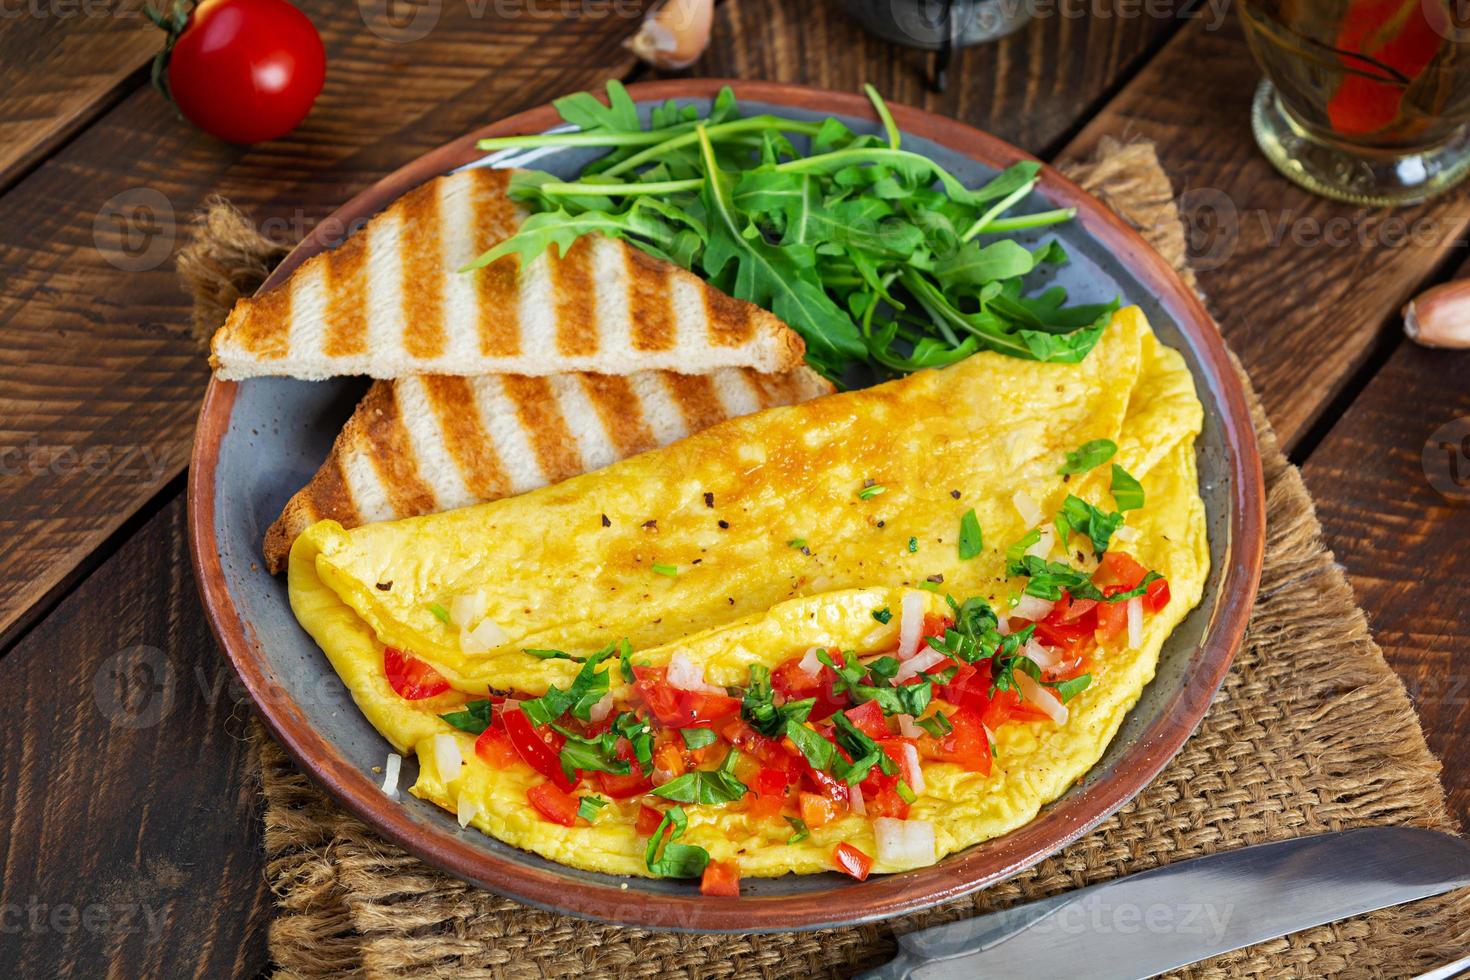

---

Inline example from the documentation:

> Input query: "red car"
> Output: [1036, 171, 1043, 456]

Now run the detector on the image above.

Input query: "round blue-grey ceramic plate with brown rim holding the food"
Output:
[188, 81, 1264, 932]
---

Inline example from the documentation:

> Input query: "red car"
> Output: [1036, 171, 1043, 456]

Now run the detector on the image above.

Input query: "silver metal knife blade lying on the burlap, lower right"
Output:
[858, 827, 1470, 980]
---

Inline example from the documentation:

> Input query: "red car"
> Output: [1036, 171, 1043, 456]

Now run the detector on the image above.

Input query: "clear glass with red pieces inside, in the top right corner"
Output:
[1241, 0, 1470, 206]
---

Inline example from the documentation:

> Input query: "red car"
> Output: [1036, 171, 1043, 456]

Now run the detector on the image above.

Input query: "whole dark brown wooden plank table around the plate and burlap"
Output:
[0, 0, 1470, 977]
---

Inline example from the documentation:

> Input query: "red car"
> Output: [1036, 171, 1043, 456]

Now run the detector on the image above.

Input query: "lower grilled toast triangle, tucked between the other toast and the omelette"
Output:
[265, 367, 832, 573]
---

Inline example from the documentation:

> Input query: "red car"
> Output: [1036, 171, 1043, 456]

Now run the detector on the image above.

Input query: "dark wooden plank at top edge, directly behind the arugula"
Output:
[695, 0, 1180, 156]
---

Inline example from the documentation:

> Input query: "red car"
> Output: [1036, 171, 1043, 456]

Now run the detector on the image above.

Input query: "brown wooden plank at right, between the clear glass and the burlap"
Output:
[1064, 18, 1470, 451]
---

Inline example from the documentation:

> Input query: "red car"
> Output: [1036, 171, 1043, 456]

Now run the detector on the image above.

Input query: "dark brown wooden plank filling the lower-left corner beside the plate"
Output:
[0, 497, 270, 977]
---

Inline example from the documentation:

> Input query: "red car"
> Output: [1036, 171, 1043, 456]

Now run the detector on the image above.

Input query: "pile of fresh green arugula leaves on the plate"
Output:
[469, 82, 1117, 382]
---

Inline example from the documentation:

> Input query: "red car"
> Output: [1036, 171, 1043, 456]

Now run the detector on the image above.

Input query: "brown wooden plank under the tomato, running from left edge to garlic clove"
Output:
[0, 0, 655, 642]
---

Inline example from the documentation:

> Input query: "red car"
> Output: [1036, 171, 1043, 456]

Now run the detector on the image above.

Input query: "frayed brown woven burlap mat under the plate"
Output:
[181, 143, 1470, 979]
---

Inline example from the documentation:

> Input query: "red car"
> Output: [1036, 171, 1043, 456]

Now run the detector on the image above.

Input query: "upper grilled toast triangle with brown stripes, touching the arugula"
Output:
[209, 167, 806, 381]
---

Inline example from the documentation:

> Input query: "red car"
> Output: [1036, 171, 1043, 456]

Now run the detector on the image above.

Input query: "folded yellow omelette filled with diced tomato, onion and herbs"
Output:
[290, 307, 1210, 895]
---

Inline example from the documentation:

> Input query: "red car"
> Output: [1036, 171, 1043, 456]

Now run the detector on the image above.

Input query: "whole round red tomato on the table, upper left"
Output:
[158, 0, 326, 143]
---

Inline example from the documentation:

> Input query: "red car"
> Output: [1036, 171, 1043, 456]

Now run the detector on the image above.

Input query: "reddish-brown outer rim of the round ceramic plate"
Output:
[188, 79, 1266, 932]
